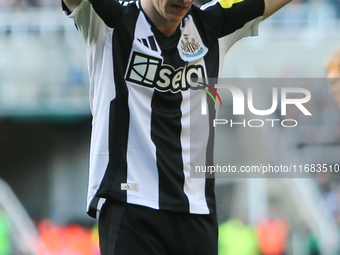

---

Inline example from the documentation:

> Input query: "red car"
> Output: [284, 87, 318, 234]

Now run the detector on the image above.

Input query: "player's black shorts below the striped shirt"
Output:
[99, 201, 218, 255]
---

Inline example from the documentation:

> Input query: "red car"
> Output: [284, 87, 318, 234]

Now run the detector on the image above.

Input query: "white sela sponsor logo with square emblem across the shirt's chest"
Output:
[125, 52, 205, 92]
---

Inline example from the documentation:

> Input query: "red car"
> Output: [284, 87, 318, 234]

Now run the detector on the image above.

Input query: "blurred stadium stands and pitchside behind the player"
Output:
[0, 0, 340, 255]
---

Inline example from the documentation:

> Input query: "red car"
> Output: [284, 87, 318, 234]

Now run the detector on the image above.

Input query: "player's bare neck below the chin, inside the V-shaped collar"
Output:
[140, 0, 180, 36]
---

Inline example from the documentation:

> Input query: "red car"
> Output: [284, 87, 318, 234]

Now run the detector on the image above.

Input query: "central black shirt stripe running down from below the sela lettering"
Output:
[151, 91, 189, 212]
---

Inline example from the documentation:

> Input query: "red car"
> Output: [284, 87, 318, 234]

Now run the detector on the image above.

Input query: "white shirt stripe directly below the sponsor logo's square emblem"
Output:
[127, 84, 159, 209]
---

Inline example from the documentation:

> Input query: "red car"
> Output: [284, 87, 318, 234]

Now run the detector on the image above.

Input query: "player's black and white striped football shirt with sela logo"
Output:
[64, 0, 264, 217]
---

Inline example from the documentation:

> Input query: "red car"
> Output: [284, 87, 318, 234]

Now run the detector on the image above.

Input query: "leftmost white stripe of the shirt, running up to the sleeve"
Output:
[83, 0, 116, 210]
